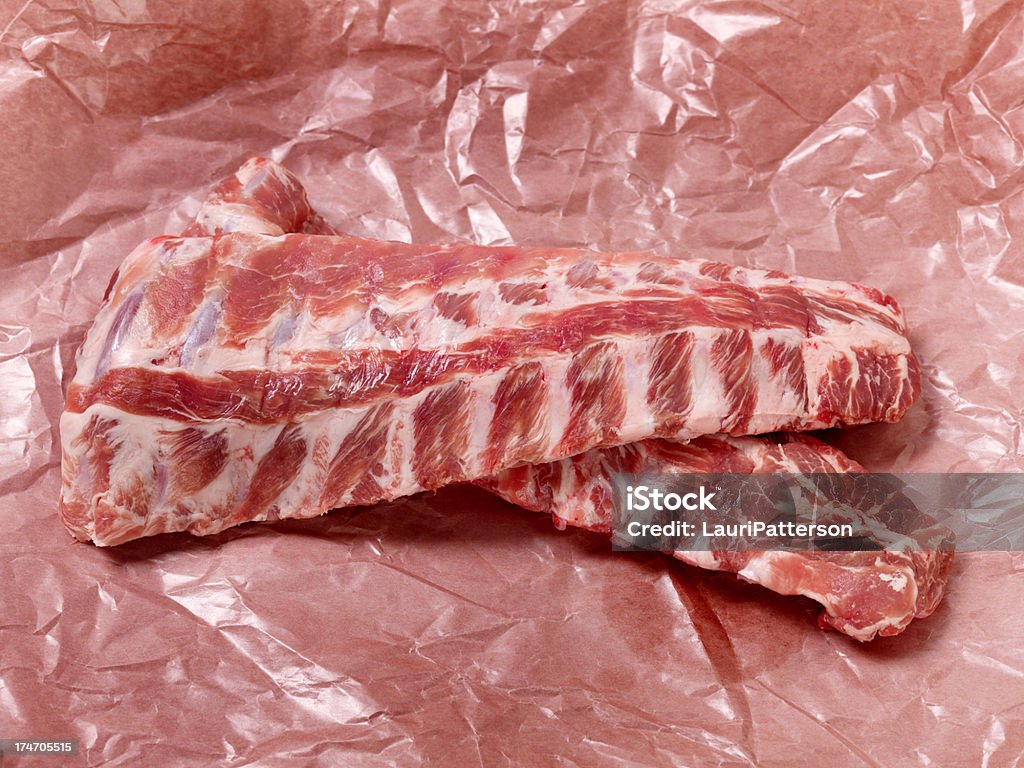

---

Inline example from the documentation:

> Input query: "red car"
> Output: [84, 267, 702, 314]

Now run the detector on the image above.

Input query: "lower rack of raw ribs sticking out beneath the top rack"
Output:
[478, 435, 953, 640]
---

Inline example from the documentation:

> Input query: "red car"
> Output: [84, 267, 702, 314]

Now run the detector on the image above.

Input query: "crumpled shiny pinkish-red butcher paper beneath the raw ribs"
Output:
[0, 0, 1024, 767]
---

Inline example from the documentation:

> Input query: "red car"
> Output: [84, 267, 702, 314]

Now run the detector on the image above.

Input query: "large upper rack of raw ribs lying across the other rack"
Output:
[61, 163, 918, 561]
